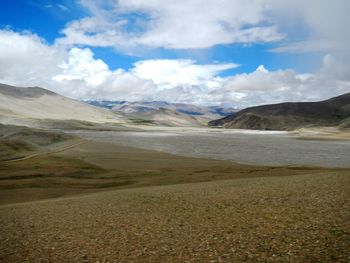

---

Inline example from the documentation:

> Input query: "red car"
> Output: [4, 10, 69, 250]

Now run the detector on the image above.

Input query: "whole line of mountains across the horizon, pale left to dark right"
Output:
[0, 84, 350, 130]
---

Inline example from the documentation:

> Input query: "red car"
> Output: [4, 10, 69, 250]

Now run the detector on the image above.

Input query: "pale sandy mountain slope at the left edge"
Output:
[0, 84, 123, 124]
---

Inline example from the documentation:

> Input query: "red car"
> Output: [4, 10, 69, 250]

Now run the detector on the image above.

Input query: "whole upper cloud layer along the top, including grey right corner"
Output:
[57, 0, 350, 54]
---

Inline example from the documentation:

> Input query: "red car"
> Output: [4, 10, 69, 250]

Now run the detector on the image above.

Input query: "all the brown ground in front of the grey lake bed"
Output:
[0, 141, 350, 263]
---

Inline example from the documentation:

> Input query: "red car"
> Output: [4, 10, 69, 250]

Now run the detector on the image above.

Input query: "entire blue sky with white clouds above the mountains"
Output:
[0, 0, 350, 108]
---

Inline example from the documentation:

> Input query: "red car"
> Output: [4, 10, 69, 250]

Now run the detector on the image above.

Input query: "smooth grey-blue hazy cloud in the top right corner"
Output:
[272, 0, 350, 57]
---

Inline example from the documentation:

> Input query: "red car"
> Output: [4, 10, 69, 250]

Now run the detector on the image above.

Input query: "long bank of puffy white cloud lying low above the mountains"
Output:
[0, 30, 350, 107]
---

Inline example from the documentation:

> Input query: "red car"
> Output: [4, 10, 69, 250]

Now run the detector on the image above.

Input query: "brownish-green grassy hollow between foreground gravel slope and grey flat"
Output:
[0, 142, 343, 204]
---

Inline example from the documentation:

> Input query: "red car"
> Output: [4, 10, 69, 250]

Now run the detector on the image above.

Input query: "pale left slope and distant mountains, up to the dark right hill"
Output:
[0, 84, 232, 128]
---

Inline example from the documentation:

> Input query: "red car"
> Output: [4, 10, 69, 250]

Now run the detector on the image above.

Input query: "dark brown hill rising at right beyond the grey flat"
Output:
[208, 93, 350, 130]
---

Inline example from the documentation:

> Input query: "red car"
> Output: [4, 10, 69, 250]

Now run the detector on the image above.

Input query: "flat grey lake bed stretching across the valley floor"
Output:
[73, 128, 350, 167]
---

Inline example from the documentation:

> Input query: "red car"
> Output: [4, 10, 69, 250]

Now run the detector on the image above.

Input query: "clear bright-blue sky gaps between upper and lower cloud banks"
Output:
[0, 0, 324, 73]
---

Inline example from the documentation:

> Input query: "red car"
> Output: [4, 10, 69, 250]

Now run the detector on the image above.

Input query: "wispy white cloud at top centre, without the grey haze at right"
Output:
[58, 0, 284, 49]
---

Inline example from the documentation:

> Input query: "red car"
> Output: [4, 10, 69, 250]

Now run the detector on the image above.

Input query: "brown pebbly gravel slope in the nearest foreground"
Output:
[0, 171, 350, 262]
